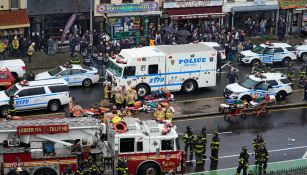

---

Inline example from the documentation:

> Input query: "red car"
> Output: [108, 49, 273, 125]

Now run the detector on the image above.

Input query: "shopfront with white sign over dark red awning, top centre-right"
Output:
[163, 0, 225, 28]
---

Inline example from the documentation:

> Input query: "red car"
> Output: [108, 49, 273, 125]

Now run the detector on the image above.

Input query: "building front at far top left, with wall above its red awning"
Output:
[0, 0, 30, 37]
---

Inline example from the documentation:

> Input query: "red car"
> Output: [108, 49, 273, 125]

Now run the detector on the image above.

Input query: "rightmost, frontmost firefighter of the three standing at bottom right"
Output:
[256, 144, 269, 174]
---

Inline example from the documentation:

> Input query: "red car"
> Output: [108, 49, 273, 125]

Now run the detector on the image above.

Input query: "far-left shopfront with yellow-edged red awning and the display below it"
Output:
[0, 9, 30, 38]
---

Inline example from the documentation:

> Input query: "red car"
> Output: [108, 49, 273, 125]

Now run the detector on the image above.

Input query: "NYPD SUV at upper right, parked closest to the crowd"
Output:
[239, 42, 296, 66]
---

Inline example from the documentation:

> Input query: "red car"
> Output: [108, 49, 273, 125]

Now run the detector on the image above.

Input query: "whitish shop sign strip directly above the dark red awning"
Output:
[163, 0, 223, 8]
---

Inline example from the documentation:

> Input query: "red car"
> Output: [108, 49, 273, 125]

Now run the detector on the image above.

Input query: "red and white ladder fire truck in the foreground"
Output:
[0, 117, 185, 175]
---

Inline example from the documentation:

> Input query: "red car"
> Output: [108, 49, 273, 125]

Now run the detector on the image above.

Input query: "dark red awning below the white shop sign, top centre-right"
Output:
[167, 6, 225, 19]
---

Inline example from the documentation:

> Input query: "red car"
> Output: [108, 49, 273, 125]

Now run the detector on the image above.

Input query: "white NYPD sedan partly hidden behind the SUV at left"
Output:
[35, 64, 99, 87]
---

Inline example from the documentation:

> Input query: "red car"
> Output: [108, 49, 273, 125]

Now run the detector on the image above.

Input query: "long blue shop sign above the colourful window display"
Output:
[96, 3, 159, 14]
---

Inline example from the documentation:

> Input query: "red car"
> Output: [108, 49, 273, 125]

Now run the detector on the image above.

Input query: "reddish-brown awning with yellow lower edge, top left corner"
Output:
[0, 10, 30, 29]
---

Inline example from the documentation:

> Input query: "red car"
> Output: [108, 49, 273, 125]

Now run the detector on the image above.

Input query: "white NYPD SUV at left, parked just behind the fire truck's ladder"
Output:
[0, 79, 70, 116]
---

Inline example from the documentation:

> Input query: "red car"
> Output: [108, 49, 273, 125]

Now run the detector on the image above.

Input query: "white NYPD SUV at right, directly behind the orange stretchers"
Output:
[224, 73, 292, 101]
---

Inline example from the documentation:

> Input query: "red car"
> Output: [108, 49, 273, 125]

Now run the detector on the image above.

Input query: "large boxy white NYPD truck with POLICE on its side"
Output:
[107, 43, 217, 97]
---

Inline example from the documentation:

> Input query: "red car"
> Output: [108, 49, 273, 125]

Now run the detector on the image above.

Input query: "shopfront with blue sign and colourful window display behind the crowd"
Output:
[95, 2, 162, 39]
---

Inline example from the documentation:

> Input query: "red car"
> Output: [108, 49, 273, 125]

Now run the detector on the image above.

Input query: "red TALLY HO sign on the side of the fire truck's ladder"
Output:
[17, 124, 69, 135]
